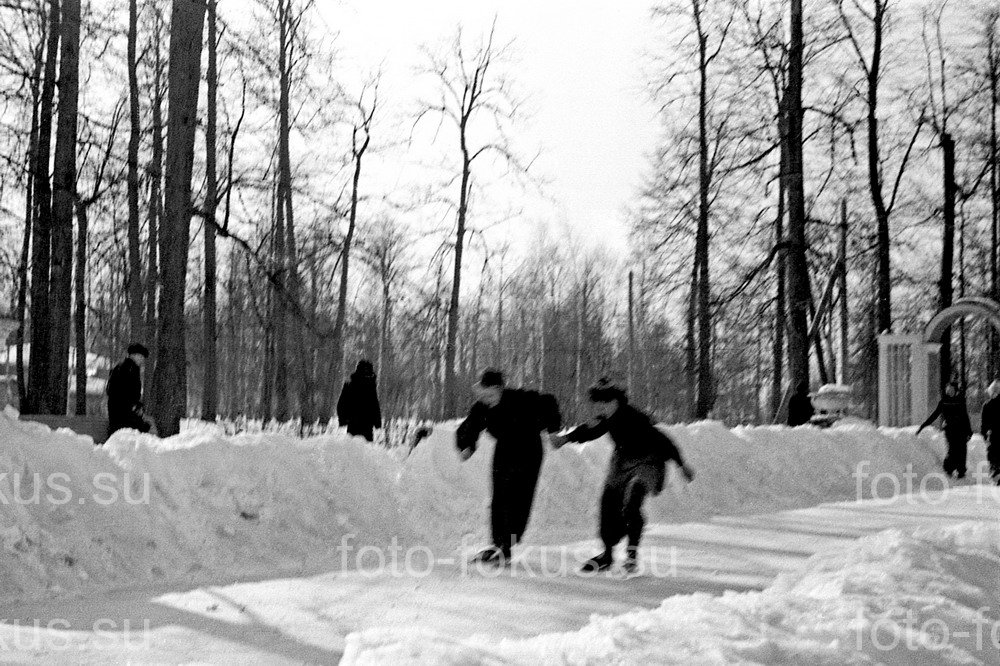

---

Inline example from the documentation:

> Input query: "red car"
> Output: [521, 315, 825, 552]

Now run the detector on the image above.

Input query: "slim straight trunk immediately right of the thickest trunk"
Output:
[201, 0, 219, 421]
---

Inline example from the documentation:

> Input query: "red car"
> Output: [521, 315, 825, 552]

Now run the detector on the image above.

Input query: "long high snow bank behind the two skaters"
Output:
[0, 404, 983, 600]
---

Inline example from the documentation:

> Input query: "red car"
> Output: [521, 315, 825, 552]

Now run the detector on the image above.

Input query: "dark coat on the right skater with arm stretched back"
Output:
[566, 404, 684, 492]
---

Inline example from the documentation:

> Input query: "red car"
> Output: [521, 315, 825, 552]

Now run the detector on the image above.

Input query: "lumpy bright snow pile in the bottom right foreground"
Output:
[342, 523, 1000, 664]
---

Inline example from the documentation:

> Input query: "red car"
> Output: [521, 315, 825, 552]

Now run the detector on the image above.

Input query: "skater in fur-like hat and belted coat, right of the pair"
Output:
[553, 379, 694, 571]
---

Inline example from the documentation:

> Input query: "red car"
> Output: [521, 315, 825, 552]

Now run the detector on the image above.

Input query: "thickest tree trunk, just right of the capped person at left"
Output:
[153, 0, 205, 436]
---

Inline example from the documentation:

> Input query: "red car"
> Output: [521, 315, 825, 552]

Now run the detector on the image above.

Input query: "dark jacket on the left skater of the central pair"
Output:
[455, 389, 562, 467]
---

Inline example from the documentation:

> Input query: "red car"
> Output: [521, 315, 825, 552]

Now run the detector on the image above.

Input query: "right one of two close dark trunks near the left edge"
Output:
[47, 0, 80, 414]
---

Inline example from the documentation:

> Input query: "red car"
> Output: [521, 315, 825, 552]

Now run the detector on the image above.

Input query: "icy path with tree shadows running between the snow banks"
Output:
[0, 486, 1000, 664]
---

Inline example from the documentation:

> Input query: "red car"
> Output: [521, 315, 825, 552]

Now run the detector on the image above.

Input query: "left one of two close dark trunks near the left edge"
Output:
[22, 0, 61, 414]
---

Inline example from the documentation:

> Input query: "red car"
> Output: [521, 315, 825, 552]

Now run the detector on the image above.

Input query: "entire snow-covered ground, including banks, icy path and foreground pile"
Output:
[0, 413, 1000, 664]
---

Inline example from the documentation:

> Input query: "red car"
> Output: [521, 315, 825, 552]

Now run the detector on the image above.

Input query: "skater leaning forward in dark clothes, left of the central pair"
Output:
[455, 369, 562, 564]
